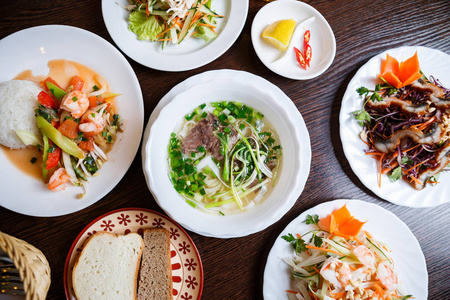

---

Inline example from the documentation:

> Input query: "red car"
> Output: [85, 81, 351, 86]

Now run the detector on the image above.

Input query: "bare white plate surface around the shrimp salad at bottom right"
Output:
[263, 199, 428, 300]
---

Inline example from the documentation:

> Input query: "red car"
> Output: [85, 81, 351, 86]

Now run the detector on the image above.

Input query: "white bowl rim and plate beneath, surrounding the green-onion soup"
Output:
[142, 70, 311, 238]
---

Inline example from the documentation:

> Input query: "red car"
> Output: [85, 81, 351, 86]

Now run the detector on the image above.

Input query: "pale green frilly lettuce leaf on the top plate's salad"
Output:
[129, 11, 163, 42]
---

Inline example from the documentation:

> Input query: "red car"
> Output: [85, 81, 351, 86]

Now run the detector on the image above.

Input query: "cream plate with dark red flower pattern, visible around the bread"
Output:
[64, 207, 203, 300]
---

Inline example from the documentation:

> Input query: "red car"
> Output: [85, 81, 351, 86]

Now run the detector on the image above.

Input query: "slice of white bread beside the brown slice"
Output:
[72, 231, 144, 300]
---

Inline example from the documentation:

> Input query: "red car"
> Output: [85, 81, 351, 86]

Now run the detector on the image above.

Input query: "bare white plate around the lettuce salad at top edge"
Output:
[102, 0, 248, 71]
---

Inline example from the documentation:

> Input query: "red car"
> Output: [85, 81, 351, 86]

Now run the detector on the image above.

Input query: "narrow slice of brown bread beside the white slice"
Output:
[137, 228, 172, 300]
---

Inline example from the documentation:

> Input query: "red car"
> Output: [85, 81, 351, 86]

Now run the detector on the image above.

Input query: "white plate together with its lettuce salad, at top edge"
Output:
[102, 0, 249, 71]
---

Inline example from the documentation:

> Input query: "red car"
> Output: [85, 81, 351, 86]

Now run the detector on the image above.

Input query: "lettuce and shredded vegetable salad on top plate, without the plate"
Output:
[125, 0, 223, 48]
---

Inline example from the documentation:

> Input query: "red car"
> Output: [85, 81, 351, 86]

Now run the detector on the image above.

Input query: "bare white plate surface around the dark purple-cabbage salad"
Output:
[339, 46, 450, 207]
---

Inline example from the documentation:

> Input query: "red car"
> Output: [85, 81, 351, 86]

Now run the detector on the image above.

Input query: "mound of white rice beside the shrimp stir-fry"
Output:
[0, 80, 42, 149]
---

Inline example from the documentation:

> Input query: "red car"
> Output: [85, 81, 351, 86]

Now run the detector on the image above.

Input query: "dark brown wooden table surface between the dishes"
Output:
[0, 0, 450, 300]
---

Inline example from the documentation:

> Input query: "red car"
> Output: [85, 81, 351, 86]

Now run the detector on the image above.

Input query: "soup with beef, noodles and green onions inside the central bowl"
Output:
[168, 101, 282, 214]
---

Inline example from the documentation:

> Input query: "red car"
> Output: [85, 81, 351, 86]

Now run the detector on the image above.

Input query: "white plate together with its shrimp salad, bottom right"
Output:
[263, 199, 428, 300]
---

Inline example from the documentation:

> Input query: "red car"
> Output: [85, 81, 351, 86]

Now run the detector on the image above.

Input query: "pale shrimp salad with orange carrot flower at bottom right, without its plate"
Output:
[282, 205, 412, 300]
